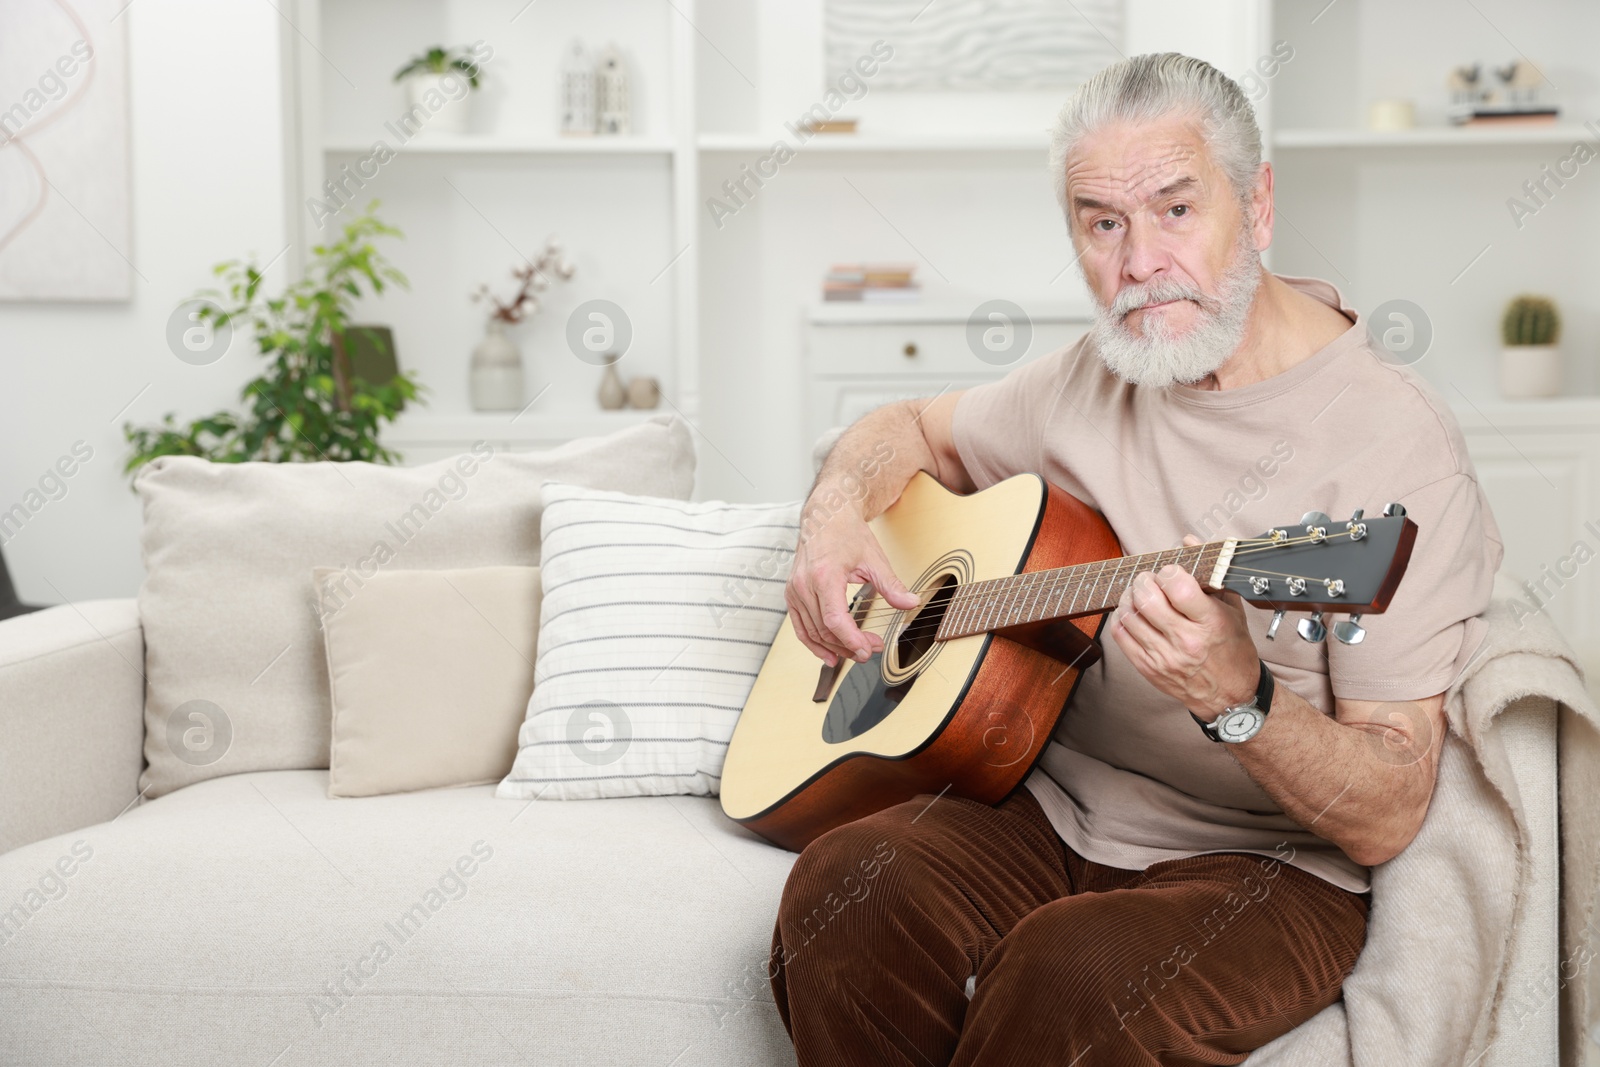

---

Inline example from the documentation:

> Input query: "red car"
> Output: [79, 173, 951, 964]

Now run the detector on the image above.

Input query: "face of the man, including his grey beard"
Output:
[1066, 117, 1262, 386]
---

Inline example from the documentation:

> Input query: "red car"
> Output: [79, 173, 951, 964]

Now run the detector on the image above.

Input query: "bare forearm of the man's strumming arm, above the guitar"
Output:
[800, 400, 938, 541]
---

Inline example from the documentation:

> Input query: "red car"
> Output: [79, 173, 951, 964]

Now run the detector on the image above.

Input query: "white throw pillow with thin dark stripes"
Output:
[496, 482, 802, 800]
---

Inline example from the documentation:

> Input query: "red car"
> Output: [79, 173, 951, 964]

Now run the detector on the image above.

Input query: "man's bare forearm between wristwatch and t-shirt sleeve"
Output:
[1227, 685, 1440, 865]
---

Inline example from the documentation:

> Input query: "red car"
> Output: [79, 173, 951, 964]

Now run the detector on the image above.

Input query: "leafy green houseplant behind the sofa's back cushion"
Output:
[123, 202, 421, 474]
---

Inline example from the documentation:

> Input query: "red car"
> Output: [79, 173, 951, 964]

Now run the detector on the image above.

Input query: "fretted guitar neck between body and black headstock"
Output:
[934, 539, 1237, 641]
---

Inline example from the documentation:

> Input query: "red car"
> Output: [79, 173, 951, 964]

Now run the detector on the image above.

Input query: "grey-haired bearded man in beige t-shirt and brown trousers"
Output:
[770, 53, 1501, 1067]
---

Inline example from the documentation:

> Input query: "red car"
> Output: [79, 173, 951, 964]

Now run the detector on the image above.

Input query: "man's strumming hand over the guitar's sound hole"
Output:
[784, 507, 918, 667]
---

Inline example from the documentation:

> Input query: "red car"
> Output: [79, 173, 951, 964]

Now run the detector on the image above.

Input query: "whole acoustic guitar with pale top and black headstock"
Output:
[722, 472, 1416, 851]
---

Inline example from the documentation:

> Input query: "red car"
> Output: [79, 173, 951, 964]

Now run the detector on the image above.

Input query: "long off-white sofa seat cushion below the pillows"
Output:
[0, 771, 795, 1067]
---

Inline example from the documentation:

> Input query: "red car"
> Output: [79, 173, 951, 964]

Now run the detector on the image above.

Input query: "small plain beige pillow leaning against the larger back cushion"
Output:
[312, 566, 539, 797]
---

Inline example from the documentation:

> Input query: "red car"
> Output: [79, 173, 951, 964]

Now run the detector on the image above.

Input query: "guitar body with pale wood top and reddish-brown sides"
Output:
[722, 472, 1122, 851]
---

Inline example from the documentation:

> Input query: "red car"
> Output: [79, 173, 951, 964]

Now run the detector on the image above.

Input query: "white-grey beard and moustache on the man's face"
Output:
[1090, 229, 1261, 389]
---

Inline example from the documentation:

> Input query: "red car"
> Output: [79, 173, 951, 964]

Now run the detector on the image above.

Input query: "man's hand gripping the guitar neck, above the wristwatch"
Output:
[1110, 537, 1261, 721]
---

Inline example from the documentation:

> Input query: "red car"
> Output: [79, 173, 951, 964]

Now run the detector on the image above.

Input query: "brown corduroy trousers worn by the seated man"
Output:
[766, 787, 1366, 1067]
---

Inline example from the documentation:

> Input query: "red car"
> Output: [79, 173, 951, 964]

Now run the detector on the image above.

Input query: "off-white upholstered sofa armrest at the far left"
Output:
[0, 600, 144, 853]
